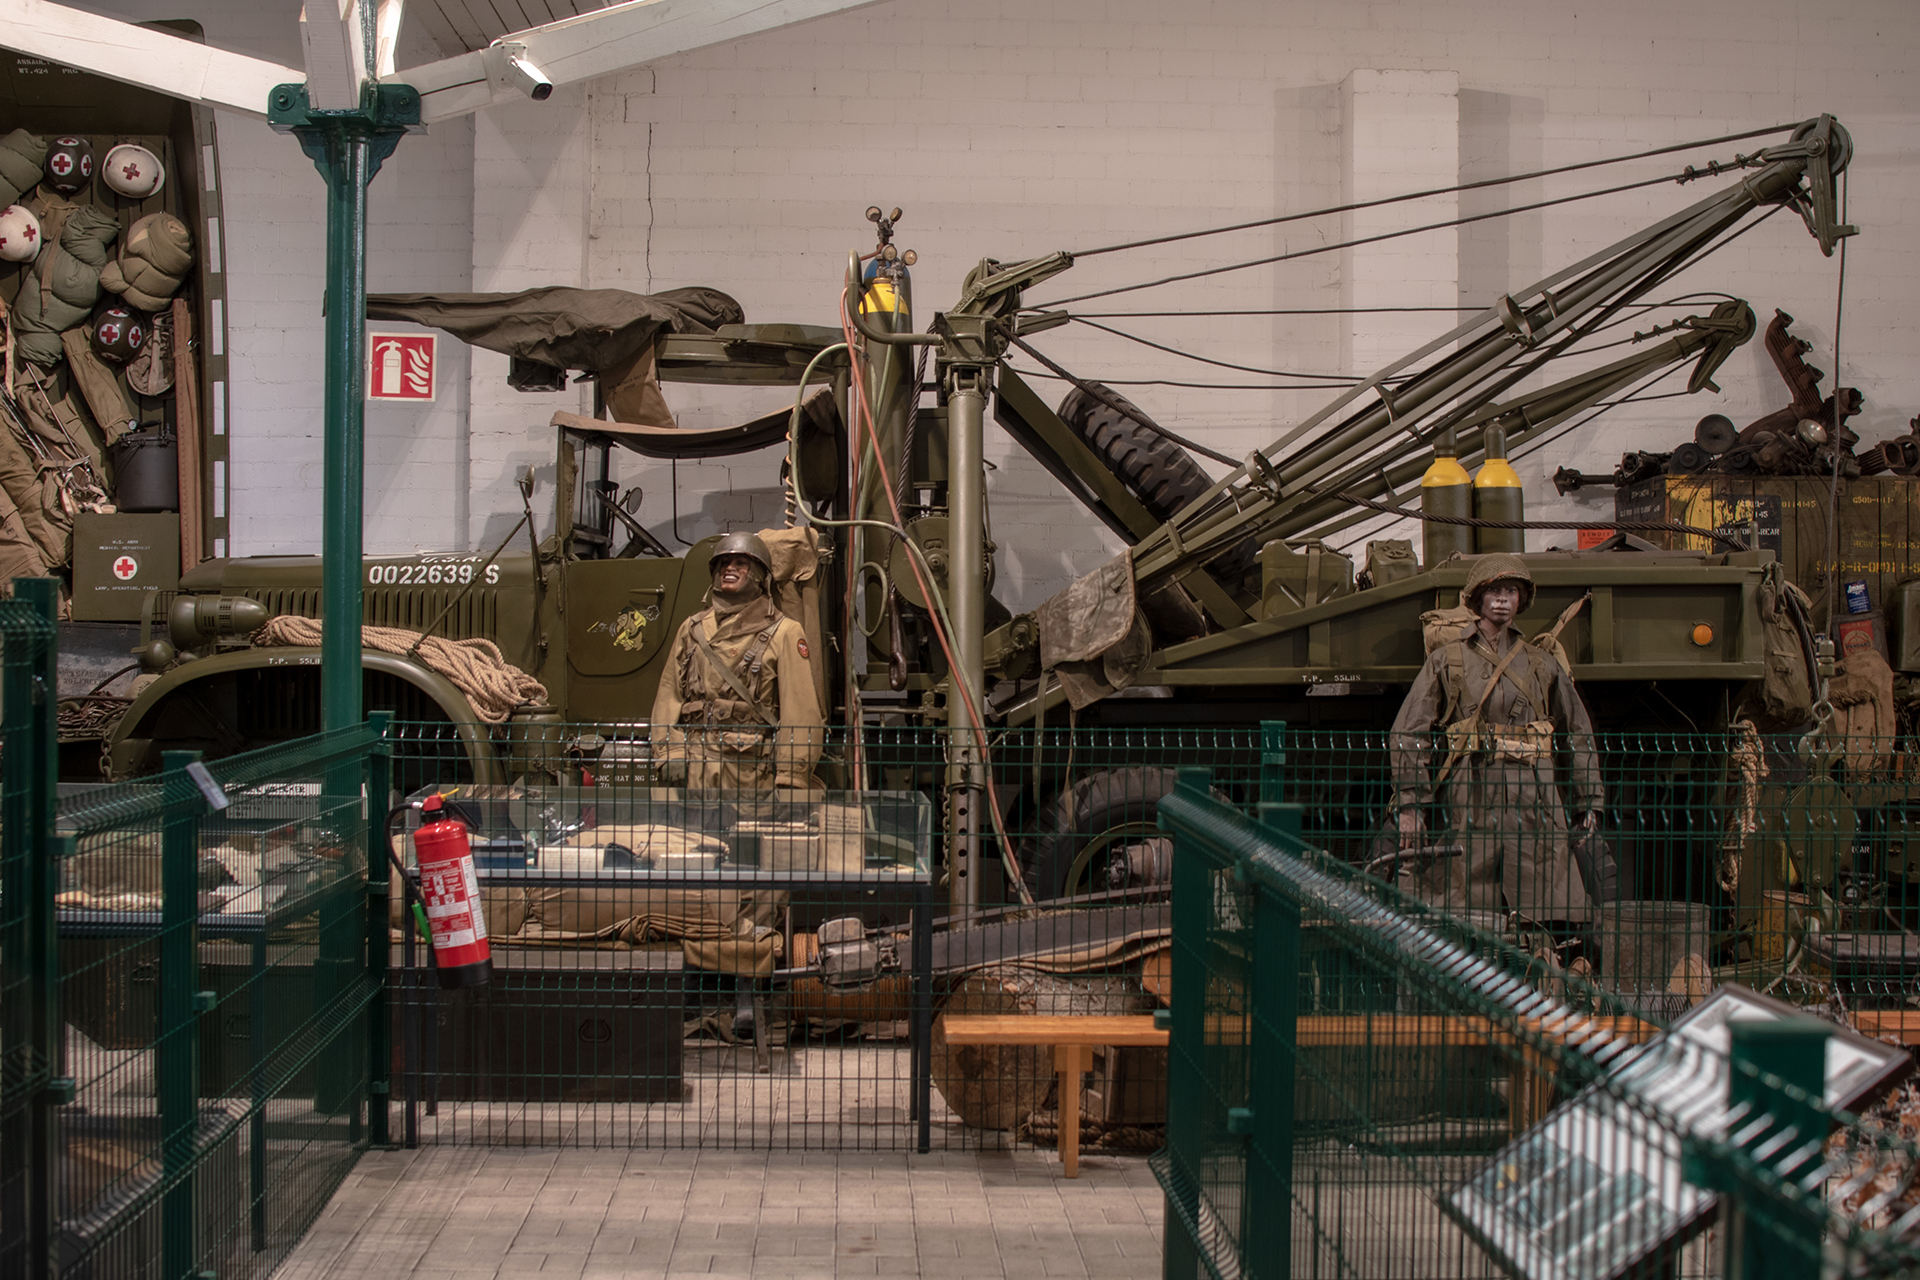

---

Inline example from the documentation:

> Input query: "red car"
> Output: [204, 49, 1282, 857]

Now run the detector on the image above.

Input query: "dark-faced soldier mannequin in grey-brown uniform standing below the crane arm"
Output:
[1390, 555, 1603, 925]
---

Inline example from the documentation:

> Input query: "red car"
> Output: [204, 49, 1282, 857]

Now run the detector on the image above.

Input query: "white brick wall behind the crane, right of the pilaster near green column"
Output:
[588, 0, 1920, 606]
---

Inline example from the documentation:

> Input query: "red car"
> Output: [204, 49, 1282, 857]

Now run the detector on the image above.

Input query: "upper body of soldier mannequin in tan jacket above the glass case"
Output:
[653, 533, 826, 791]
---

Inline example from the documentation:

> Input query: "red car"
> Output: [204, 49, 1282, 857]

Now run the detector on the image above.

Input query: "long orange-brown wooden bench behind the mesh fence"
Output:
[941, 1013, 1659, 1178]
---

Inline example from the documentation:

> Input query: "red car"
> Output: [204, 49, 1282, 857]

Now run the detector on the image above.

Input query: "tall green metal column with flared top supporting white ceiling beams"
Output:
[267, 84, 420, 736]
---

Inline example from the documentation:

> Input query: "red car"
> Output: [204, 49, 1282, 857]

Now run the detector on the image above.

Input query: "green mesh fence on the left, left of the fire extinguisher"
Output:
[0, 633, 390, 1278]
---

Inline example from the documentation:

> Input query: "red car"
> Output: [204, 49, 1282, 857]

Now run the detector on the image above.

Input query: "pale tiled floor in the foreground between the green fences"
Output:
[275, 1148, 1160, 1280]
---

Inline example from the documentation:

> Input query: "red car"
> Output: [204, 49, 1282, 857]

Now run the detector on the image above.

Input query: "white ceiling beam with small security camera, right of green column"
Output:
[382, 0, 876, 123]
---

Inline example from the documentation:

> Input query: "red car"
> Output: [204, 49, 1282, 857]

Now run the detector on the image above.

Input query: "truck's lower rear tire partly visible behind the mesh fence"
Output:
[1020, 766, 1179, 898]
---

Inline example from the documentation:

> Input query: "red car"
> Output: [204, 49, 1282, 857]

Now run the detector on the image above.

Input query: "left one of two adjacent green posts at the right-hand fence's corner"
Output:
[1160, 768, 1219, 1280]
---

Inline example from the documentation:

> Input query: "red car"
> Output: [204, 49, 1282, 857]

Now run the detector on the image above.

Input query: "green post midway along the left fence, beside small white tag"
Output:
[154, 750, 204, 1280]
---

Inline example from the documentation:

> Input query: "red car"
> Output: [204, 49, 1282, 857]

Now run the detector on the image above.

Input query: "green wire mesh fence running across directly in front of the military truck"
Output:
[353, 723, 1920, 1151]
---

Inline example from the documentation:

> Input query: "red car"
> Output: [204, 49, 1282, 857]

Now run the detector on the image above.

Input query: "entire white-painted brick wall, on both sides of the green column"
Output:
[78, 0, 1920, 606]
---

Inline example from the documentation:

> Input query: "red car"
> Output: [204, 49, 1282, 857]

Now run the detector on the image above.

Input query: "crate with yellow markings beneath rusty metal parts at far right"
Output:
[1615, 474, 1920, 629]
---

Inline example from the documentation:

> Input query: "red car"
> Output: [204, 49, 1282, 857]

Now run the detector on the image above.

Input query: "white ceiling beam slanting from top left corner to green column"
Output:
[0, 0, 299, 119]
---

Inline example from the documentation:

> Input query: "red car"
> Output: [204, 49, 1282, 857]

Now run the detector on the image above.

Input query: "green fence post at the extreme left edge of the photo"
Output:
[0, 578, 65, 1276]
